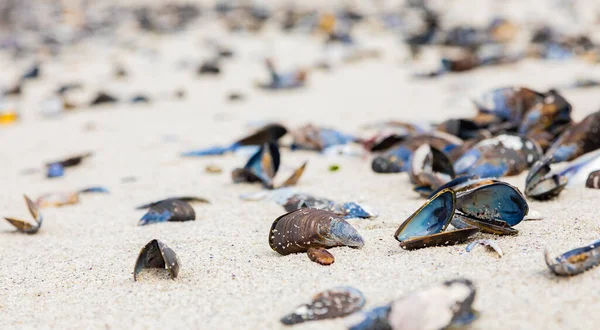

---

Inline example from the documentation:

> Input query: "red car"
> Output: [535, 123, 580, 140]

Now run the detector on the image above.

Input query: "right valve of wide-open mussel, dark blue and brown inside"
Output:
[456, 182, 529, 227]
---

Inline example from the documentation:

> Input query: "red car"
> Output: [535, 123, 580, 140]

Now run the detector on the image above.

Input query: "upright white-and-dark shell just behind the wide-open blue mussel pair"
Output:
[409, 144, 455, 196]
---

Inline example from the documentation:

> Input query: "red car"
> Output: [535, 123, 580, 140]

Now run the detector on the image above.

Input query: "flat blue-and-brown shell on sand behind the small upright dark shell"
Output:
[137, 196, 209, 226]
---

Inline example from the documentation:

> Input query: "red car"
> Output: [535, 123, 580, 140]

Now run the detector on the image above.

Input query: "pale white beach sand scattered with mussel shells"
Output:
[0, 1, 600, 329]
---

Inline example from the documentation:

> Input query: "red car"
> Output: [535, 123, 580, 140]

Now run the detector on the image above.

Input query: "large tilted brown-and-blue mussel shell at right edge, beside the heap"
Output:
[546, 111, 600, 163]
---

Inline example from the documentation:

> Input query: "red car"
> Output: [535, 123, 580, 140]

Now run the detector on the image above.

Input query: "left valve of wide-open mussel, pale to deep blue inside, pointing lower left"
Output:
[394, 189, 456, 242]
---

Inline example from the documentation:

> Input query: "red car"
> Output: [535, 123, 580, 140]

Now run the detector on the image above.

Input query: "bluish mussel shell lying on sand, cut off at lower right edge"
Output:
[544, 240, 600, 276]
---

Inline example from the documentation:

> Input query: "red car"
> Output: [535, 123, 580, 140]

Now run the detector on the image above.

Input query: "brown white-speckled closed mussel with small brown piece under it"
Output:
[269, 208, 365, 264]
